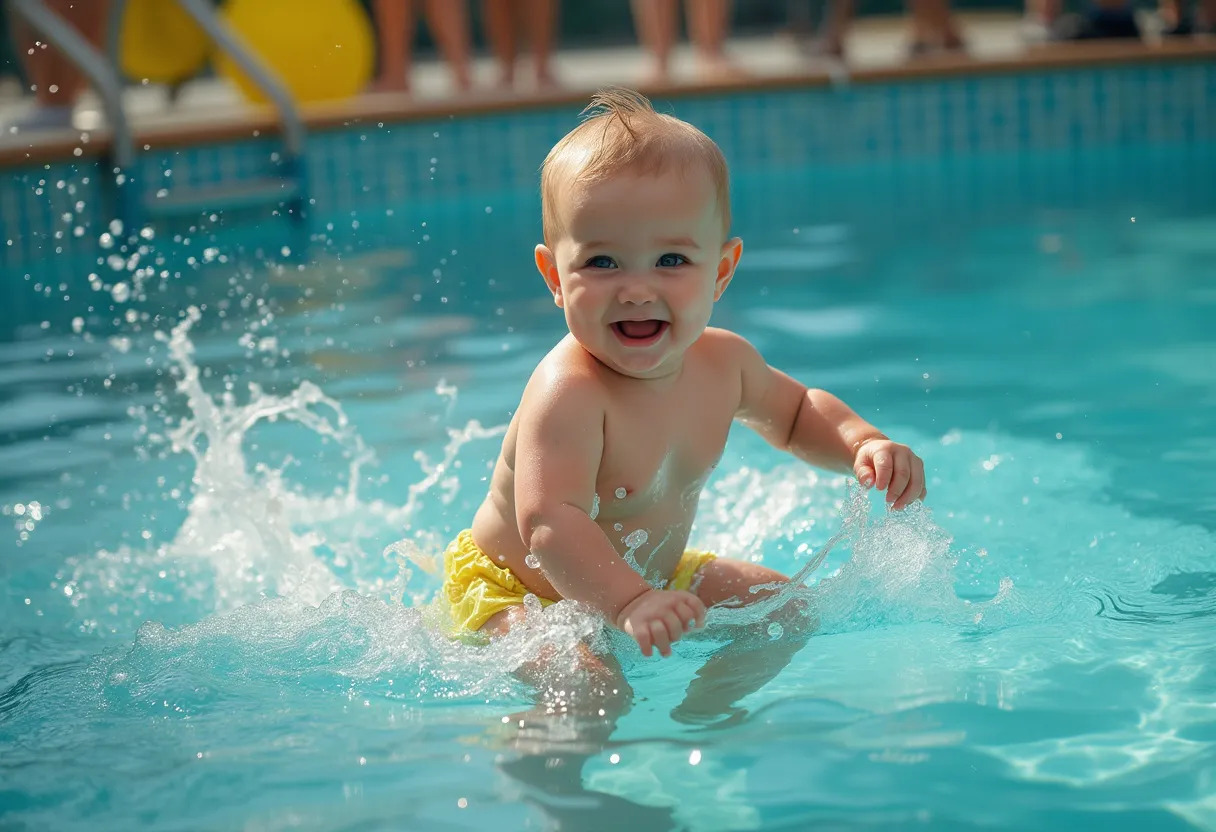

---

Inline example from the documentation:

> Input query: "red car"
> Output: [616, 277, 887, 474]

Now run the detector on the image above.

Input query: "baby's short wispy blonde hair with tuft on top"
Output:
[540, 88, 731, 246]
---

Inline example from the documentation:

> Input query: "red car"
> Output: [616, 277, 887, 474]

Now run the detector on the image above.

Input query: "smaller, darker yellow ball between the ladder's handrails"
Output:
[118, 0, 212, 84]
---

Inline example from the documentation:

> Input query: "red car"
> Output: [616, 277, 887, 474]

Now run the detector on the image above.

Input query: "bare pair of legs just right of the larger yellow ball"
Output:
[375, 0, 473, 92]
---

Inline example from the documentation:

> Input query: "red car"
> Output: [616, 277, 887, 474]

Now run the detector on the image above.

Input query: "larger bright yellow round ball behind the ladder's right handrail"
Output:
[215, 0, 375, 103]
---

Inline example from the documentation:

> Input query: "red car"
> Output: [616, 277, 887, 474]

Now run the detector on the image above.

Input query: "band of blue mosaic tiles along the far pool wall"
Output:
[0, 62, 1216, 279]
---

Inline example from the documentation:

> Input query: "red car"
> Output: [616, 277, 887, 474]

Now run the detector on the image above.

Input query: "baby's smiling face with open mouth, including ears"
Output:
[537, 170, 739, 378]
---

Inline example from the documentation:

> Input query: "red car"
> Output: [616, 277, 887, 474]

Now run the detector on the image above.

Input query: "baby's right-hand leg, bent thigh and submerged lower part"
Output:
[671, 557, 815, 724]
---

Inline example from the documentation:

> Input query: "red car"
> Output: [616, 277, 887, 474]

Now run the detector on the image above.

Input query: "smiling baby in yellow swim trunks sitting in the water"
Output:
[444, 90, 925, 656]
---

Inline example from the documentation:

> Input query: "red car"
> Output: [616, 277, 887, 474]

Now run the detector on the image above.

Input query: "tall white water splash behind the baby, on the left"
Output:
[56, 307, 505, 629]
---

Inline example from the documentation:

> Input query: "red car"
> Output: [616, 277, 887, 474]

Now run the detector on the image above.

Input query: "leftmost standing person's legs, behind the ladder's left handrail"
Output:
[10, 0, 109, 130]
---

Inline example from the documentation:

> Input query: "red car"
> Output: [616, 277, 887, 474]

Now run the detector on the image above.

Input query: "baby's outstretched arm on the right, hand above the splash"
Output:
[728, 333, 925, 508]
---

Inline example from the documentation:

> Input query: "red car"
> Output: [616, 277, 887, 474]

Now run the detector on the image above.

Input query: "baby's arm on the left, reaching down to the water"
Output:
[516, 377, 705, 656]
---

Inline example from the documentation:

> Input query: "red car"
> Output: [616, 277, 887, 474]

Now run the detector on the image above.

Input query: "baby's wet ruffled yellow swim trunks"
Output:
[443, 529, 717, 631]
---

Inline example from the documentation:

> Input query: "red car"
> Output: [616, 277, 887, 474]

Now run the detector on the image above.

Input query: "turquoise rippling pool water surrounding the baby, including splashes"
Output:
[0, 147, 1216, 830]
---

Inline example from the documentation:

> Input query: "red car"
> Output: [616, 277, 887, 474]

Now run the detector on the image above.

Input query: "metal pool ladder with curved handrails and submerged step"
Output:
[9, 0, 309, 229]
